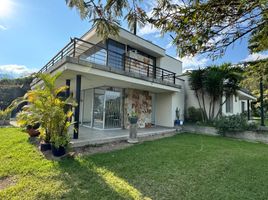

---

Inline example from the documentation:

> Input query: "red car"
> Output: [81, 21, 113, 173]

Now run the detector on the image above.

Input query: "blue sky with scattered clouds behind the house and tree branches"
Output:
[0, 0, 268, 77]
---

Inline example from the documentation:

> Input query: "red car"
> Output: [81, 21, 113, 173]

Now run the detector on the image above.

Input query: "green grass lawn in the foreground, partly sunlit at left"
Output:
[0, 128, 268, 200]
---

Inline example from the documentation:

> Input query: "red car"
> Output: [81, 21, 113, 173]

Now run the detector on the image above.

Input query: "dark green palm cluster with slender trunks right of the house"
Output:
[189, 64, 241, 121]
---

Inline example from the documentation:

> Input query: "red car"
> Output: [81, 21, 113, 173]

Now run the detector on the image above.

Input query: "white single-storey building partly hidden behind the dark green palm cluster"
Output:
[182, 76, 256, 117]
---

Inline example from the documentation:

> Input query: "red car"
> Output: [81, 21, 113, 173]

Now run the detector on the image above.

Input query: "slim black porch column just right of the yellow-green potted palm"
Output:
[73, 75, 81, 139]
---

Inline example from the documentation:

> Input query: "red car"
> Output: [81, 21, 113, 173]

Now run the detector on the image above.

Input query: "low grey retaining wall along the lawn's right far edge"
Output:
[182, 125, 268, 144]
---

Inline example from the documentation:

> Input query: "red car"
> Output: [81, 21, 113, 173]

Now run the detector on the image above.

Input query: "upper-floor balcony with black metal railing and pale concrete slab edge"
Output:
[35, 38, 183, 88]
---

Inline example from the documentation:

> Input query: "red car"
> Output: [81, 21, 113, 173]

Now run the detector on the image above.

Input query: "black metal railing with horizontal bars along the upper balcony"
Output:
[38, 38, 182, 84]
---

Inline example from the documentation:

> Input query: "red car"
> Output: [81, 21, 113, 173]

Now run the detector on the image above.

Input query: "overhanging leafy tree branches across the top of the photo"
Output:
[66, 0, 268, 57]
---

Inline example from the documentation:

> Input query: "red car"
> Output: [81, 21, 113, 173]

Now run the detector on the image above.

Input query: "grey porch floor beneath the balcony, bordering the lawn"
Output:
[70, 126, 176, 147]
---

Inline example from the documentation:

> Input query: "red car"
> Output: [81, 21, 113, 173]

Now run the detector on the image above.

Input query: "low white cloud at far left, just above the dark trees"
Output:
[0, 64, 37, 77]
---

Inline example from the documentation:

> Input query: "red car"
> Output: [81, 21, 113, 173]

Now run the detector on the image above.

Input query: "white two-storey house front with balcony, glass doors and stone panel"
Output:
[32, 28, 184, 138]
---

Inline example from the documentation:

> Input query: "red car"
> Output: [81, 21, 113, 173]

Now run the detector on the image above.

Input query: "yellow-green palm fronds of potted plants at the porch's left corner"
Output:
[14, 73, 76, 147]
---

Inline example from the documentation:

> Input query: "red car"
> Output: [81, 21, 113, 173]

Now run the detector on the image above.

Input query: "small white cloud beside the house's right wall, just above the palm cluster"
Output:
[179, 55, 209, 71]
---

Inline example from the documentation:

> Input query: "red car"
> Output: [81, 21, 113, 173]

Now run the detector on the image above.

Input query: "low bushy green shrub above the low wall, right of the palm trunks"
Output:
[215, 114, 256, 135]
